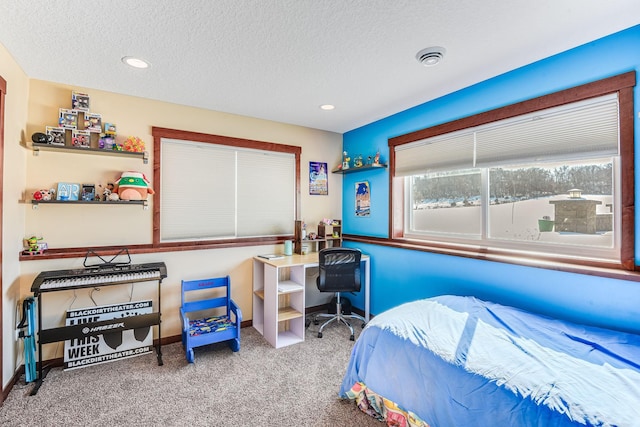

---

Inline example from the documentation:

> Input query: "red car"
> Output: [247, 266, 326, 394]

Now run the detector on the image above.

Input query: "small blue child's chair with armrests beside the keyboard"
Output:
[180, 276, 242, 363]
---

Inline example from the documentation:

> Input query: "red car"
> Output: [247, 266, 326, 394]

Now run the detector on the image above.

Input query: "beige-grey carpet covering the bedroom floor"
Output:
[0, 324, 383, 427]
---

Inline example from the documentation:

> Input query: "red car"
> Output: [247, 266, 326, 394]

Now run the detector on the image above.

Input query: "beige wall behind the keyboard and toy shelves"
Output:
[5, 58, 342, 388]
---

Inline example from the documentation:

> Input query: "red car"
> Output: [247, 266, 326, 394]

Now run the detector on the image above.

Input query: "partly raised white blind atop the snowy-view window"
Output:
[395, 94, 619, 176]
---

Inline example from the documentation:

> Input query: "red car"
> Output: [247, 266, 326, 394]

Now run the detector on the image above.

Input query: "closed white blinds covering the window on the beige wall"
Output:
[160, 138, 296, 242]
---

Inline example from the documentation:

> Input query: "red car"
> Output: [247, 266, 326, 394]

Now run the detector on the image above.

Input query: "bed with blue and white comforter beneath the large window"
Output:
[340, 295, 640, 427]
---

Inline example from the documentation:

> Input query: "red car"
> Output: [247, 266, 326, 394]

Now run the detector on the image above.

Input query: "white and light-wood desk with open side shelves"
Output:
[253, 252, 370, 348]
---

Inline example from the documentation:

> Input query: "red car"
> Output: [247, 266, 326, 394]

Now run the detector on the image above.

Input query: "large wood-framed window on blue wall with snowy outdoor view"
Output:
[390, 74, 635, 265]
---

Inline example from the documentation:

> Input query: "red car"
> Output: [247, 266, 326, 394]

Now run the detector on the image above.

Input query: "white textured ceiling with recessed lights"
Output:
[0, 0, 640, 133]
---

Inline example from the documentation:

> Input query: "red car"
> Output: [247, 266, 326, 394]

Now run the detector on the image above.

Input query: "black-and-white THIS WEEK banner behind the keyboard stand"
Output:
[64, 301, 153, 370]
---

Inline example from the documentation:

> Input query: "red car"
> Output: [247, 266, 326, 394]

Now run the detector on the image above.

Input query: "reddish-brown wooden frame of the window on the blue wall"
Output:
[378, 71, 640, 281]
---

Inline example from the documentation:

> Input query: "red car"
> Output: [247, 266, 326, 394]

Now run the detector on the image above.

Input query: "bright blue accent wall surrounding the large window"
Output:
[342, 26, 640, 333]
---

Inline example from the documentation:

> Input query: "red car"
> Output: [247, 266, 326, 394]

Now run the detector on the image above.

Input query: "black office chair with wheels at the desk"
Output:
[313, 247, 366, 341]
